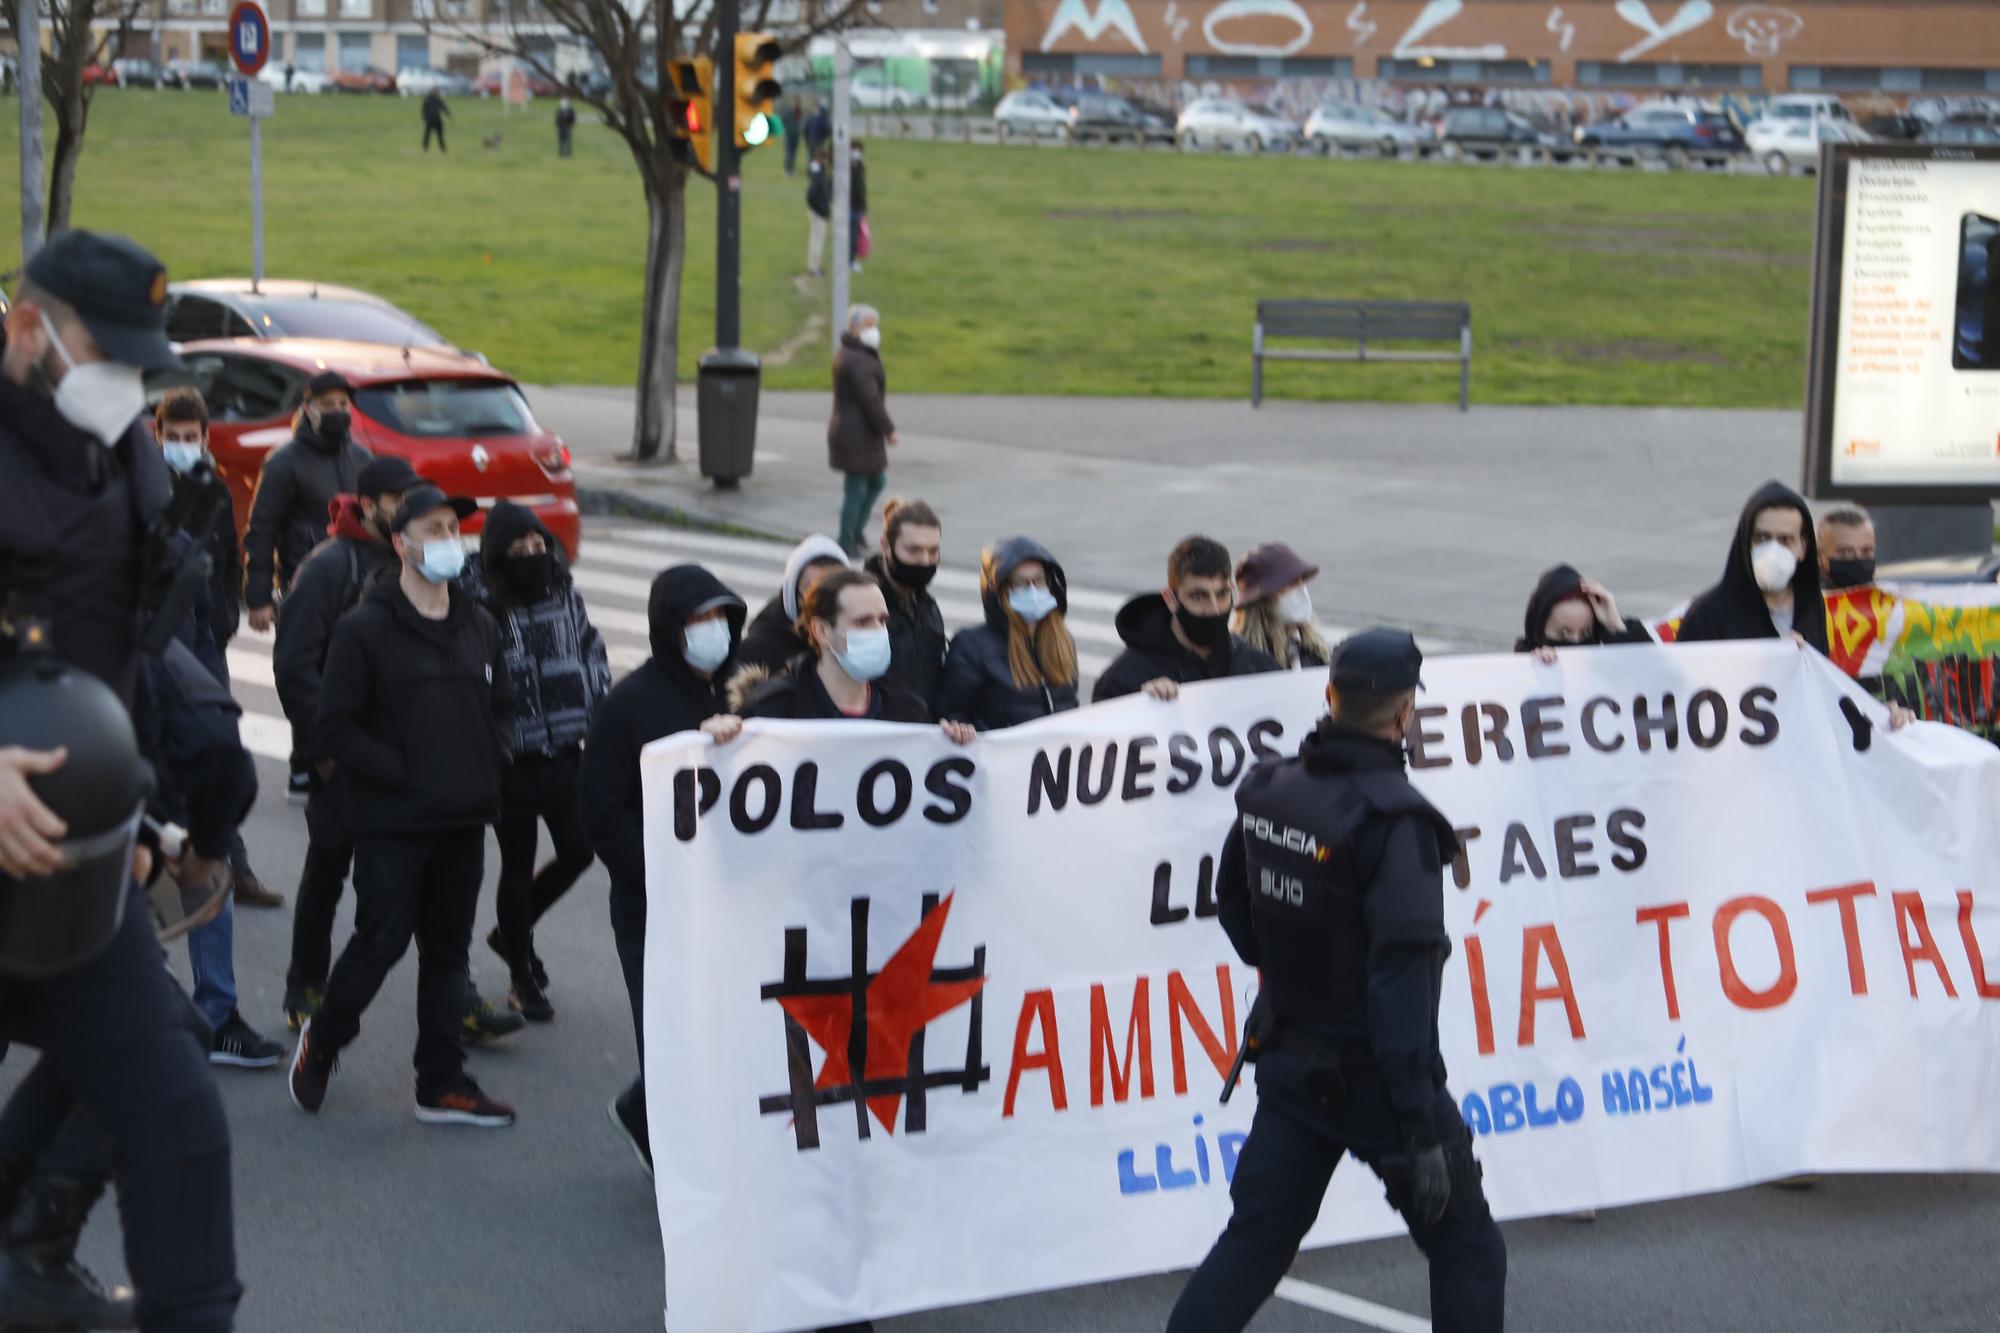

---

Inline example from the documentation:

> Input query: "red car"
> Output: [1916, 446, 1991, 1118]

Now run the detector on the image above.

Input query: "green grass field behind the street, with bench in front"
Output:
[0, 90, 1812, 406]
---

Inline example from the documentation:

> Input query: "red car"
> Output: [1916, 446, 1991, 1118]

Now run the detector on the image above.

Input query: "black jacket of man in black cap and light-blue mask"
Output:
[318, 578, 514, 833]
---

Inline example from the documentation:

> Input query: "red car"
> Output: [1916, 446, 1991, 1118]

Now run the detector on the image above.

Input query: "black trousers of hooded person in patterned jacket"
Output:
[494, 747, 596, 973]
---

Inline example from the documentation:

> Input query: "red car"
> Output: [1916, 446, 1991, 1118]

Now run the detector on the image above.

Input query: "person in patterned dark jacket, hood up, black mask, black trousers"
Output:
[480, 500, 612, 1023]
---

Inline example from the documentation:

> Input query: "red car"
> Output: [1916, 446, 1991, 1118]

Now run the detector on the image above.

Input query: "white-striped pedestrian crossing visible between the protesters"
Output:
[228, 520, 1408, 761]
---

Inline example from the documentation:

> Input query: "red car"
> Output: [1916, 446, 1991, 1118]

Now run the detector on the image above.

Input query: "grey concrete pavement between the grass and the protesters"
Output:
[530, 382, 1802, 646]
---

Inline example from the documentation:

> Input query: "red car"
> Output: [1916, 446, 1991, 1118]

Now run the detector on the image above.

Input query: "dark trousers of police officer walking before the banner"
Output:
[1166, 1051, 1506, 1333]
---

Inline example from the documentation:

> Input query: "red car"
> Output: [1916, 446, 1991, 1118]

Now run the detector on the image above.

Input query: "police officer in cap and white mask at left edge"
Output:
[0, 230, 242, 1333]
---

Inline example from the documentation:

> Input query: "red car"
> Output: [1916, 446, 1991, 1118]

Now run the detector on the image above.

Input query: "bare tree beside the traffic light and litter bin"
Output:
[430, 0, 860, 462]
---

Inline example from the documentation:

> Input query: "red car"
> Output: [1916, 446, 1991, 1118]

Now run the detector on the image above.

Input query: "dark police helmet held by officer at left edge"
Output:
[0, 652, 152, 981]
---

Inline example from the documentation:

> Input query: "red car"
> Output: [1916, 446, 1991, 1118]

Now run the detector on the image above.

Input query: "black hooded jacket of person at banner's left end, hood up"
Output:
[576, 564, 744, 895]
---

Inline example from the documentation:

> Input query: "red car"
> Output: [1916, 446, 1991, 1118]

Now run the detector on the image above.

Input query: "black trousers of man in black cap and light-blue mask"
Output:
[312, 827, 486, 1097]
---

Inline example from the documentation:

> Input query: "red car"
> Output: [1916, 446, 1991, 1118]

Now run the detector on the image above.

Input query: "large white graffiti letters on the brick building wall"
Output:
[1042, 0, 1806, 64]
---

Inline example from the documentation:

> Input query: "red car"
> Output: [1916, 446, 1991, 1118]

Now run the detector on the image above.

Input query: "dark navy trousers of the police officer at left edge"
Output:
[0, 887, 242, 1333]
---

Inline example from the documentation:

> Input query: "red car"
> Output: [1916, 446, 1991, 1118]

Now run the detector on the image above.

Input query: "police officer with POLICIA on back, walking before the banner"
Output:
[1166, 628, 1506, 1333]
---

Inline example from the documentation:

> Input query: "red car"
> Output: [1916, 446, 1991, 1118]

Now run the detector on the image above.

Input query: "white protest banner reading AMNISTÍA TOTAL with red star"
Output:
[642, 642, 2000, 1333]
